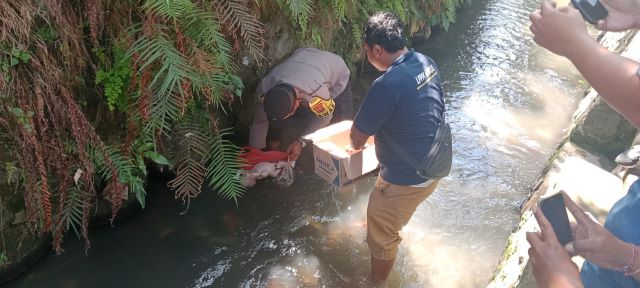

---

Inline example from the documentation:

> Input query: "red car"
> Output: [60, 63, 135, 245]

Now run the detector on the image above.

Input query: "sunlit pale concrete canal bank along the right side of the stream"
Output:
[488, 30, 640, 287]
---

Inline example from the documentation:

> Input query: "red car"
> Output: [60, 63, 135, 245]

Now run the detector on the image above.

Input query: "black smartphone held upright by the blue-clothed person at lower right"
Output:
[539, 193, 573, 246]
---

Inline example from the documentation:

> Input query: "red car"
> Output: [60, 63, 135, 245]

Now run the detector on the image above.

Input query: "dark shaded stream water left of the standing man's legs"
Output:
[6, 170, 384, 287]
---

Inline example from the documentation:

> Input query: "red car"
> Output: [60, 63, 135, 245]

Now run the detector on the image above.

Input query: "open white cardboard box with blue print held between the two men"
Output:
[304, 121, 378, 188]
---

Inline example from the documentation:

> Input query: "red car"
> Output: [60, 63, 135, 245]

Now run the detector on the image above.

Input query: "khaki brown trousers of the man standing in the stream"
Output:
[367, 176, 438, 260]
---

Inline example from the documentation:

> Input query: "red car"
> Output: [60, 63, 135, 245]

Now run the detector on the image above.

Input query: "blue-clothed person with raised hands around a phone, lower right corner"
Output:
[527, 192, 640, 287]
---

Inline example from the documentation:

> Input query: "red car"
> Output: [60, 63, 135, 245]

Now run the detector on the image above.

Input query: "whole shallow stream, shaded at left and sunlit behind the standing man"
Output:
[7, 0, 583, 287]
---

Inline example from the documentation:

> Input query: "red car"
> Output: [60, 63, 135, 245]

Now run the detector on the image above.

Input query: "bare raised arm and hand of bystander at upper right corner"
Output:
[529, 1, 640, 127]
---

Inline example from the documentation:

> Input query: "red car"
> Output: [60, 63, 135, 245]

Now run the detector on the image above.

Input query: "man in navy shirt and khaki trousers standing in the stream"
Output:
[348, 12, 444, 281]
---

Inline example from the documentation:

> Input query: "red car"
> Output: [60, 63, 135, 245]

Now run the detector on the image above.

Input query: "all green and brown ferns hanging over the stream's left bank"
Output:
[0, 0, 462, 252]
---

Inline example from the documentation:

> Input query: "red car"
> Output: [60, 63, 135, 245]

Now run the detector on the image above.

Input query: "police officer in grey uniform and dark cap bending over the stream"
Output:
[249, 48, 353, 160]
